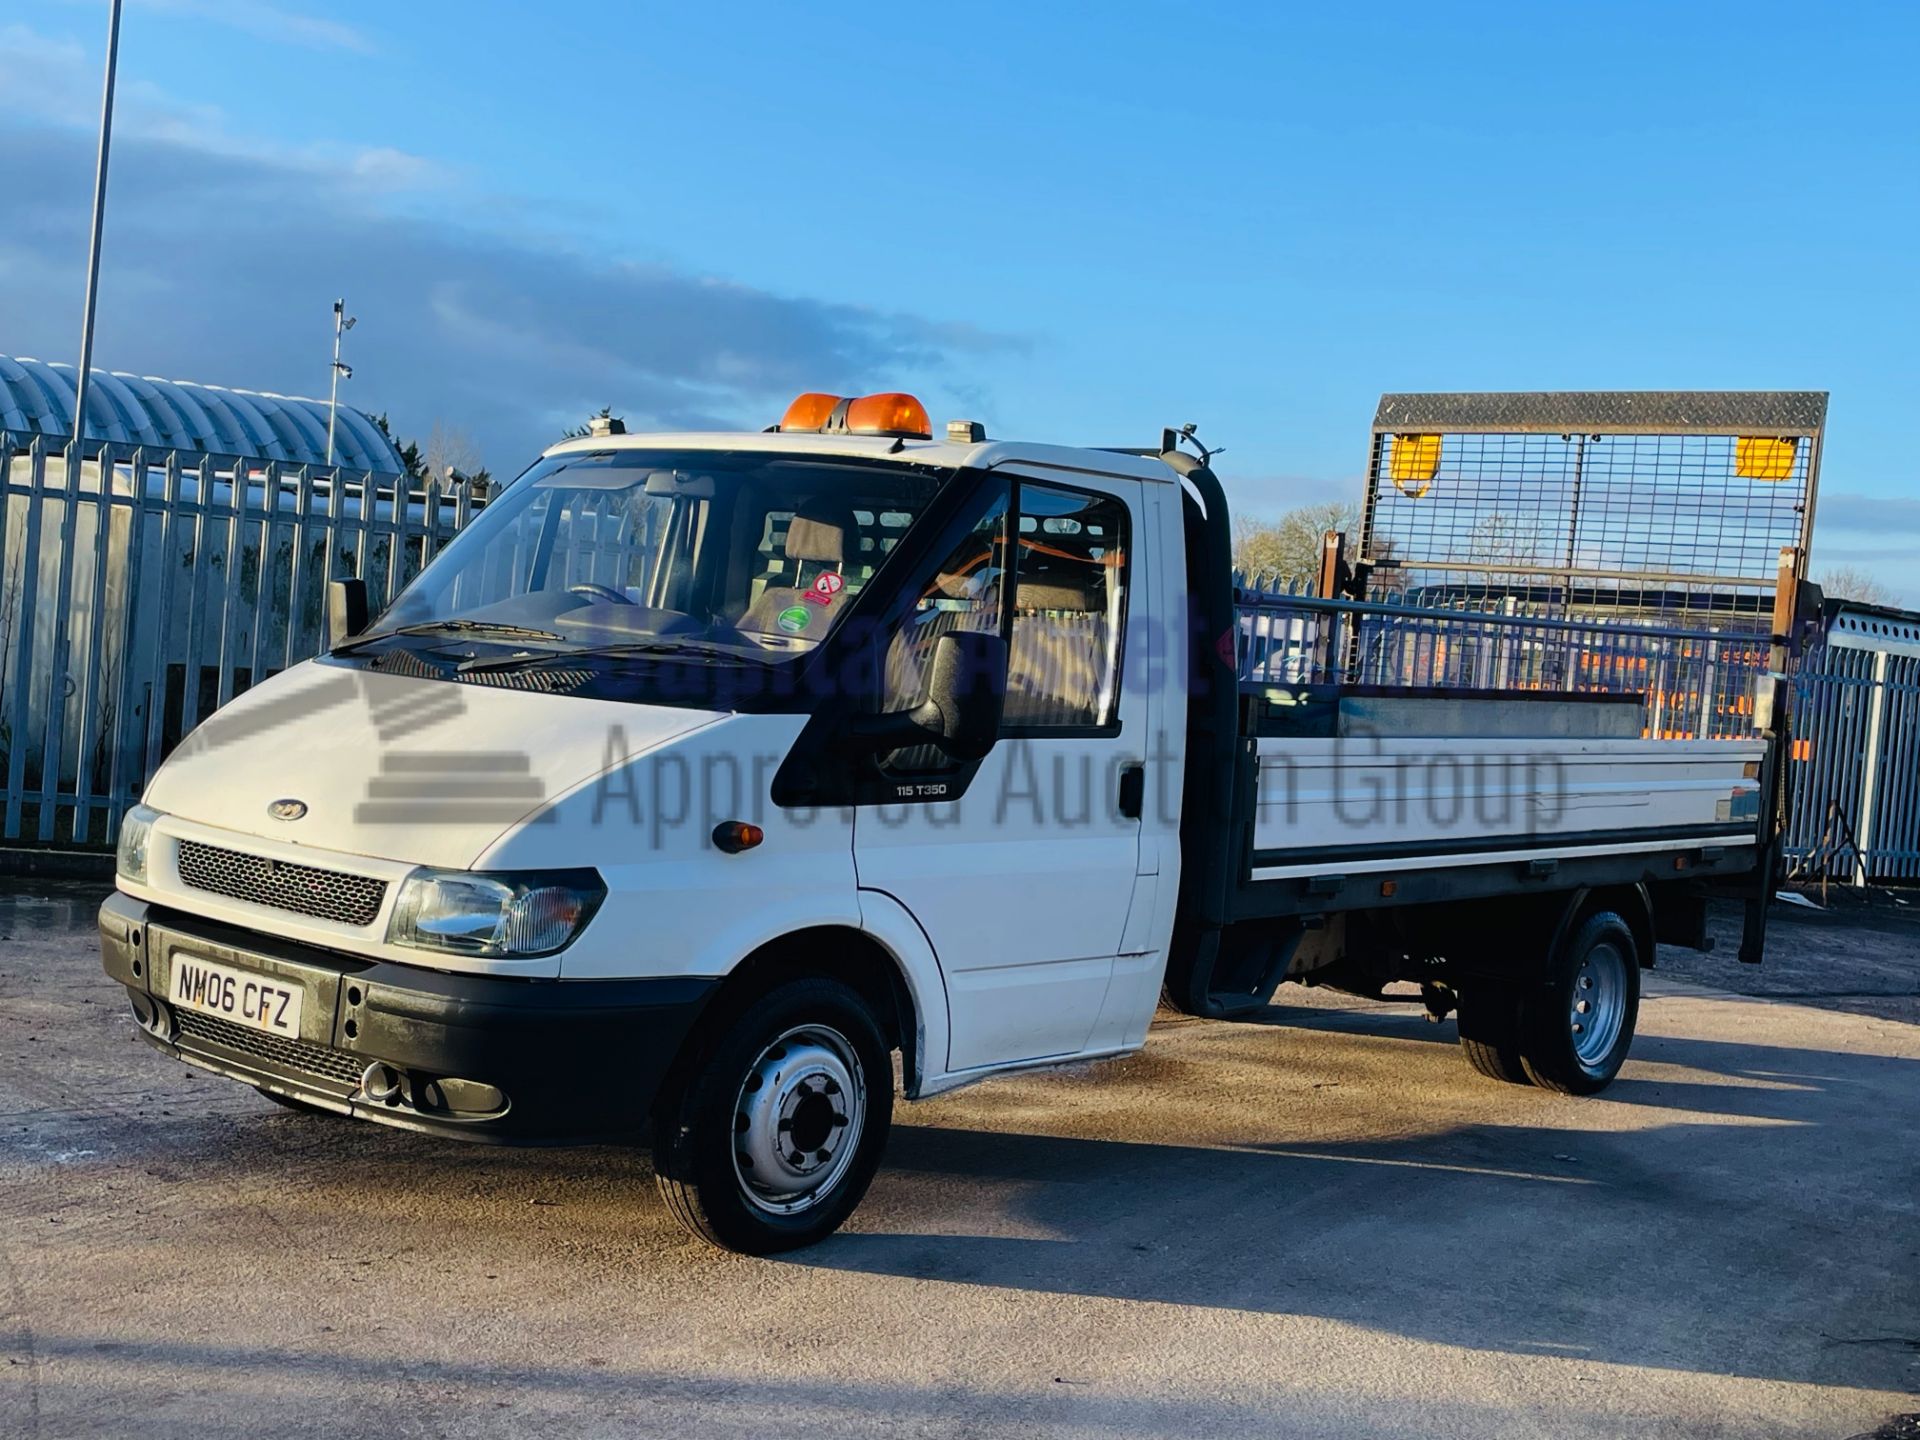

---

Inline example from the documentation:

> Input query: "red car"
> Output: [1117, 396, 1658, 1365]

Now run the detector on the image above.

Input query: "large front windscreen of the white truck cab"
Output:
[362, 449, 945, 660]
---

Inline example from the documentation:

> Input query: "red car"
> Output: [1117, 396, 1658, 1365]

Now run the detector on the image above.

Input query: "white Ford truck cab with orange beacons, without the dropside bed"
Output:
[100, 396, 1185, 1248]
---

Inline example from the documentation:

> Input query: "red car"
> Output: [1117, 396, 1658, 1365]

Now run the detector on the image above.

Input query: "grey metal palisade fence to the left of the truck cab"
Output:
[0, 430, 476, 849]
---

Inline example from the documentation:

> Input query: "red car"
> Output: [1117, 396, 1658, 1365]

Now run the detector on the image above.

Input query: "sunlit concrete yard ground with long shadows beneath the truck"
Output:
[0, 881, 1920, 1440]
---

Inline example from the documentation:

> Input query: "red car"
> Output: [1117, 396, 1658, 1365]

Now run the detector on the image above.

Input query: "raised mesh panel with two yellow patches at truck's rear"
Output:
[1361, 390, 1826, 626]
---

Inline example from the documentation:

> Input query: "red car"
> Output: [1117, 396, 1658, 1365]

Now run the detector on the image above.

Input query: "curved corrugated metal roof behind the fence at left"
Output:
[0, 355, 405, 474]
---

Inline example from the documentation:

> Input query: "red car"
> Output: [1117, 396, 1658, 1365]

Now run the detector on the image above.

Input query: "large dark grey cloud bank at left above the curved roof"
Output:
[0, 84, 1010, 468]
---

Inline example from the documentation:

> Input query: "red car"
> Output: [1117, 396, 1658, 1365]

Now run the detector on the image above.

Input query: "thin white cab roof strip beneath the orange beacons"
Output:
[543, 430, 1179, 484]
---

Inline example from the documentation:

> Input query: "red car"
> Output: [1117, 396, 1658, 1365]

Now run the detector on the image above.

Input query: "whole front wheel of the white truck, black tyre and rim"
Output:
[653, 977, 893, 1256]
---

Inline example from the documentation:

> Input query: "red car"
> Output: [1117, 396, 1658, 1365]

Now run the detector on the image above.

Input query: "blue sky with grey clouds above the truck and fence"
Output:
[0, 0, 1920, 601]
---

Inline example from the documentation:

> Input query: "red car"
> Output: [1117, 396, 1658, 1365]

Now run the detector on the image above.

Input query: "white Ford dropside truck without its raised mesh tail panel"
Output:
[100, 396, 1780, 1252]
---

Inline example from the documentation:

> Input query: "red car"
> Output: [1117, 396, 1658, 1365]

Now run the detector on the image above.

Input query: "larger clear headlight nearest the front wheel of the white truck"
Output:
[386, 870, 607, 958]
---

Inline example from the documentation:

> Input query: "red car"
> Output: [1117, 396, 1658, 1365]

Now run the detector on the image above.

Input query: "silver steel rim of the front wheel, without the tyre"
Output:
[733, 1025, 866, 1215]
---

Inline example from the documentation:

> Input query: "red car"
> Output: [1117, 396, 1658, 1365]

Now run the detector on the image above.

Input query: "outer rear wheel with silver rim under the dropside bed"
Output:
[1521, 910, 1640, 1094]
